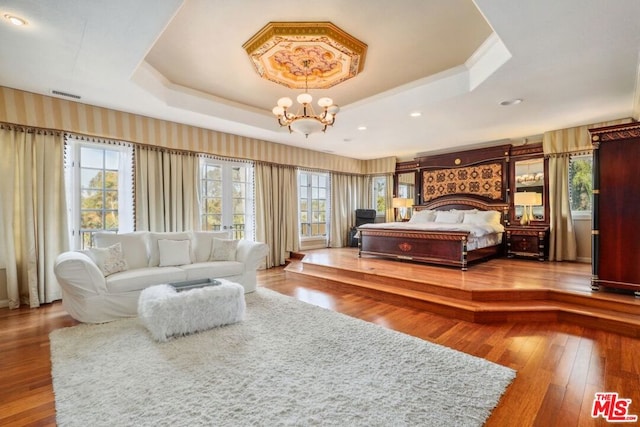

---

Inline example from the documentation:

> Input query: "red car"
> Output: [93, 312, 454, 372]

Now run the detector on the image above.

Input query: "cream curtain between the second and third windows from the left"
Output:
[255, 163, 300, 268]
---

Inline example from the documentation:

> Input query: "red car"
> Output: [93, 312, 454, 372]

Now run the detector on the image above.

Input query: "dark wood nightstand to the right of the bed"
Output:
[505, 225, 549, 261]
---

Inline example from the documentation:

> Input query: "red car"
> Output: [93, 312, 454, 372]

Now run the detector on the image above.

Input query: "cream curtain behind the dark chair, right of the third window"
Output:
[329, 172, 364, 248]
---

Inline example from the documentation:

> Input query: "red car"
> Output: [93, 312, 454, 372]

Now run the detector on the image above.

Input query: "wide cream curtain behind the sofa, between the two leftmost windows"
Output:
[135, 146, 200, 231]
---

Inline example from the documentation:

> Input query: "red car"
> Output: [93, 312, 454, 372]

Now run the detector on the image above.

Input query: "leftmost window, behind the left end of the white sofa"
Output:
[65, 139, 133, 249]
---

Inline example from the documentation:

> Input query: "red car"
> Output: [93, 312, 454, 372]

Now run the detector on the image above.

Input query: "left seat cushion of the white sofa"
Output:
[106, 267, 187, 294]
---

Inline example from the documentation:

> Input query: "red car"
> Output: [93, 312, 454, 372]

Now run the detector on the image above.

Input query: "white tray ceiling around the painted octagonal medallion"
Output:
[0, 0, 640, 160]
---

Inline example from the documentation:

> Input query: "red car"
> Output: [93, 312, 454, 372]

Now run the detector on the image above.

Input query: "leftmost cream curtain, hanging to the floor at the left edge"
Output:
[0, 125, 69, 308]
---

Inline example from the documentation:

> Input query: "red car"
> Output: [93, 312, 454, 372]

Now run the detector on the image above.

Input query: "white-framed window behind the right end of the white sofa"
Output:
[200, 159, 254, 240]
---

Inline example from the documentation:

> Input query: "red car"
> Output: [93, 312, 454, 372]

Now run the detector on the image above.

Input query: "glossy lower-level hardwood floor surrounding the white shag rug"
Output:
[0, 261, 640, 427]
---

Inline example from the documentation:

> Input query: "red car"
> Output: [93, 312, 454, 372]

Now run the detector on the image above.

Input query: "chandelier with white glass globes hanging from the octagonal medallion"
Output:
[271, 59, 340, 138]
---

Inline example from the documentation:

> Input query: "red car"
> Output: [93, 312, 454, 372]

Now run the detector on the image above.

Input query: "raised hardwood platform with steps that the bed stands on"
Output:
[286, 249, 640, 337]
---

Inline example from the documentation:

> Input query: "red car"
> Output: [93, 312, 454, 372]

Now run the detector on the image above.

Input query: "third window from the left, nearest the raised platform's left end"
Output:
[298, 171, 329, 240]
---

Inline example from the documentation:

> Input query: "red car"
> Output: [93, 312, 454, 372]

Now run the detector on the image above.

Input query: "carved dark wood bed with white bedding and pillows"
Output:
[358, 196, 508, 271]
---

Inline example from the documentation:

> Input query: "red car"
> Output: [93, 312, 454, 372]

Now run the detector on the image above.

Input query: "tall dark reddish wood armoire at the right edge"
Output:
[590, 123, 640, 297]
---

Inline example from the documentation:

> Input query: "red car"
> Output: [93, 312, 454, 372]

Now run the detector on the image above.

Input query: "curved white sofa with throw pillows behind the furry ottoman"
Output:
[54, 231, 269, 323]
